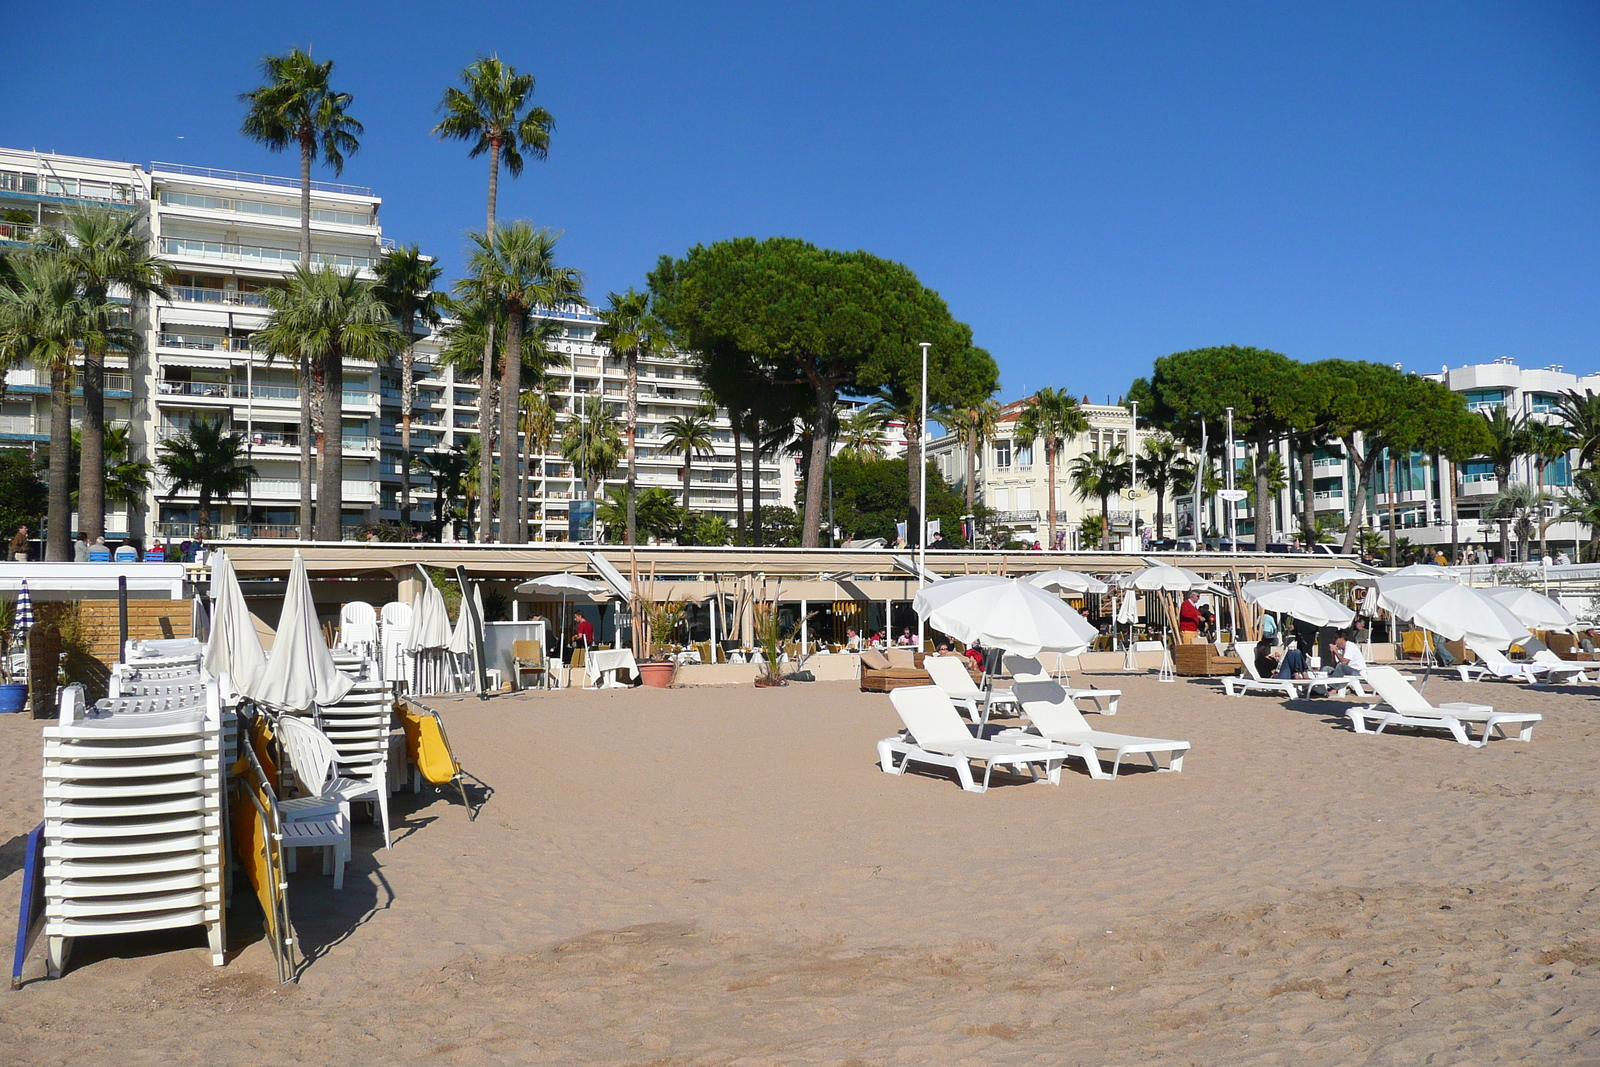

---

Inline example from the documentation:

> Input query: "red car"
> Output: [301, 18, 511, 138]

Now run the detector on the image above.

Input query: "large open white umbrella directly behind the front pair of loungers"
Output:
[912, 574, 1099, 656]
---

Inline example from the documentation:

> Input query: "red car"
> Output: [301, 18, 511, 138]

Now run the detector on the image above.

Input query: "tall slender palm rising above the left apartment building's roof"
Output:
[238, 48, 365, 541]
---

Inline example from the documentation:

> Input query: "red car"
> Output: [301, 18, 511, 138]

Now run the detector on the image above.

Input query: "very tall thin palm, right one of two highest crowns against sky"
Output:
[434, 56, 555, 541]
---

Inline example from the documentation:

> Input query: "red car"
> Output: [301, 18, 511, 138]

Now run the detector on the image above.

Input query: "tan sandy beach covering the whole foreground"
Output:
[0, 675, 1600, 1065]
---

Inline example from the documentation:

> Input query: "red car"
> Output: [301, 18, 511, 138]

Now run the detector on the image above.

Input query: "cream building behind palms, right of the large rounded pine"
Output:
[928, 400, 1176, 550]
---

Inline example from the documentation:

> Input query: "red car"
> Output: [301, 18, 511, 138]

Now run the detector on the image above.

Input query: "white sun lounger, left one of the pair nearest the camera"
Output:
[878, 685, 1067, 793]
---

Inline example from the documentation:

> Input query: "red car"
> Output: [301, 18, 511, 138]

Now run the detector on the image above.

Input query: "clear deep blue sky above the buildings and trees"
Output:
[0, 0, 1600, 400]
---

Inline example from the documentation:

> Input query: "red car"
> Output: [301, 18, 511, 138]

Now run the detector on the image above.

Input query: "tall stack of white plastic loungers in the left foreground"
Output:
[45, 683, 226, 977]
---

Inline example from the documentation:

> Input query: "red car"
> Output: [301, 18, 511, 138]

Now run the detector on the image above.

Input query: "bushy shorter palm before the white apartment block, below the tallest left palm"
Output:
[254, 264, 405, 541]
